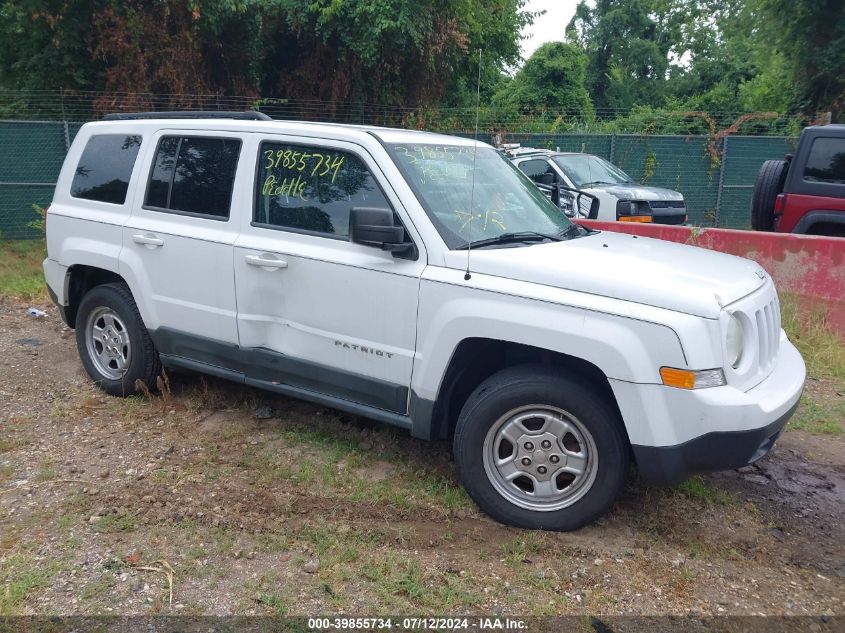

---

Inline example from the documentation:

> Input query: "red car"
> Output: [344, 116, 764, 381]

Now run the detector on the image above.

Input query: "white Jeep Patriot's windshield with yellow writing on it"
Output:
[387, 143, 572, 249]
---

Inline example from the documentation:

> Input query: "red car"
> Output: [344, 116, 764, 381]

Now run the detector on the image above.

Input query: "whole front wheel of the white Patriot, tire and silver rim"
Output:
[454, 365, 629, 531]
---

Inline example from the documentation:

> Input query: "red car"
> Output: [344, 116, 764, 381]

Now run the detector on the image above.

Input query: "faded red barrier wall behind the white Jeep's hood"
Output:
[578, 220, 845, 336]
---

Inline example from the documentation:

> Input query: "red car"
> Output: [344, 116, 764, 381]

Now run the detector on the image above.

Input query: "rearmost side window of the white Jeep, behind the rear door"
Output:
[70, 134, 141, 204]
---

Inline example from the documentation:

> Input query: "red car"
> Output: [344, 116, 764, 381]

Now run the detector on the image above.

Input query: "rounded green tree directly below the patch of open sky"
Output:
[493, 42, 593, 118]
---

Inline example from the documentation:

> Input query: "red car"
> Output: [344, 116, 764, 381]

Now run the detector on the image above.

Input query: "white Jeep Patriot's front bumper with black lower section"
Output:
[620, 334, 806, 485]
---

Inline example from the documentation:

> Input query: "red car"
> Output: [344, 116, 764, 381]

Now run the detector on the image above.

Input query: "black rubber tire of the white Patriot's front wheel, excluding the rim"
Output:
[453, 365, 630, 531]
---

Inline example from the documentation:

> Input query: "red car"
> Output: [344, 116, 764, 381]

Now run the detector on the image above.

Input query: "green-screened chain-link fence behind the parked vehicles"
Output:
[0, 121, 796, 239]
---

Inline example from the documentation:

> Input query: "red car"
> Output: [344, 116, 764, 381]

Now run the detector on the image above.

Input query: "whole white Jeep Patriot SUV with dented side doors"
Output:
[44, 113, 805, 530]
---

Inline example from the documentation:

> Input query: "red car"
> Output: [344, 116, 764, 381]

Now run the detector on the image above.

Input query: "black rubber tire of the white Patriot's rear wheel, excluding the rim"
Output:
[76, 283, 161, 396]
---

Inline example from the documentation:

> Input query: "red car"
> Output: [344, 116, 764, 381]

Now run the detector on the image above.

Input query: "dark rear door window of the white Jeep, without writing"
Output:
[145, 136, 241, 220]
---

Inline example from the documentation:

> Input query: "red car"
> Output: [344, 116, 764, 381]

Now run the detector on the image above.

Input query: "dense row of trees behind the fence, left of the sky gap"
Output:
[0, 0, 534, 116]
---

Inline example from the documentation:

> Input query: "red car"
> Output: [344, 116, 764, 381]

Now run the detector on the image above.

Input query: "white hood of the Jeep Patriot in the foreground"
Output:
[446, 231, 767, 319]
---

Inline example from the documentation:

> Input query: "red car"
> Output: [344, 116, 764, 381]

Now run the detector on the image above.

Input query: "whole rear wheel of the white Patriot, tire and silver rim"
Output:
[76, 283, 161, 396]
